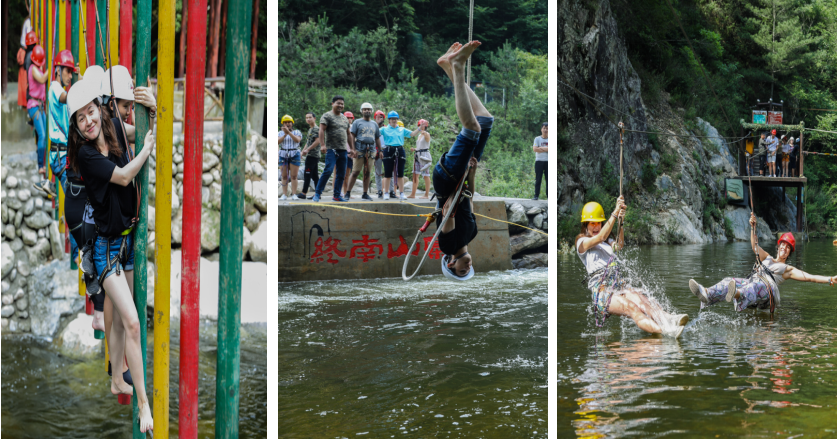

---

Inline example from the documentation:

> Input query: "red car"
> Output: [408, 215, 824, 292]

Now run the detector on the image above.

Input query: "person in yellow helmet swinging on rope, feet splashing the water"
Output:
[575, 196, 689, 338]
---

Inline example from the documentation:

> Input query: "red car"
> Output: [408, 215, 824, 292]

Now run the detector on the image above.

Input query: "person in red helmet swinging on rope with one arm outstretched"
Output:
[689, 213, 837, 312]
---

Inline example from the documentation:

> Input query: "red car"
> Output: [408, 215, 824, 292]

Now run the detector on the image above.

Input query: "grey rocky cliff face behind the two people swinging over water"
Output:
[557, 0, 796, 243]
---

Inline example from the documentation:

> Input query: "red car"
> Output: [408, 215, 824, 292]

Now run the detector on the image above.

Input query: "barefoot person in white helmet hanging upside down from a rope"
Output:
[432, 41, 494, 280]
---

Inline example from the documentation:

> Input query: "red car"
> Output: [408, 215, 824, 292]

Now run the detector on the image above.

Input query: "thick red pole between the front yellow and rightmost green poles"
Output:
[179, 0, 207, 439]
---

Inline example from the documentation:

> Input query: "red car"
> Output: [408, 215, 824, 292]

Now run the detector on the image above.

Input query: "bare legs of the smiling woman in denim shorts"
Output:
[103, 271, 154, 432]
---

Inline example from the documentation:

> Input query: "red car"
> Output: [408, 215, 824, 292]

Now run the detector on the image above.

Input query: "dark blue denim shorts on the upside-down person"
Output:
[433, 116, 494, 198]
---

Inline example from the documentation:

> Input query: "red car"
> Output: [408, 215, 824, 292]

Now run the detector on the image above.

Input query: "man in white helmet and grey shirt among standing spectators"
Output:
[346, 102, 381, 201]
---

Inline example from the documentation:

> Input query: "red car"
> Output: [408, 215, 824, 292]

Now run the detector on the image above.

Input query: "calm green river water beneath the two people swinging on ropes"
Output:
[556, 241, 837, 438]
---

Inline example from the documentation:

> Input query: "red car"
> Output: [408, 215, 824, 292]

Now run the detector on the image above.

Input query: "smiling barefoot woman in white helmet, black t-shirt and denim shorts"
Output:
[67, 76, 155, 432]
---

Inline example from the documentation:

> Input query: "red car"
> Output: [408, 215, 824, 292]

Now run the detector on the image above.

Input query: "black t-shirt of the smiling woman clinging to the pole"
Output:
[78, 118, 137, 237]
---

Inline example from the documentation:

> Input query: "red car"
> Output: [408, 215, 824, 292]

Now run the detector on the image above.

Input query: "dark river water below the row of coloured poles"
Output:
[2, 322, 267, 439]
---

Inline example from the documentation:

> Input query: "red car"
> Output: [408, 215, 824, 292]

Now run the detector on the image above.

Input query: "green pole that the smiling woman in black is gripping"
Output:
[133, 0, 152, 439]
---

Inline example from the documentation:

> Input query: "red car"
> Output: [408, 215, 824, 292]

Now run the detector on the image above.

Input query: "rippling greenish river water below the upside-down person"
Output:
[278, 269, 548, 438]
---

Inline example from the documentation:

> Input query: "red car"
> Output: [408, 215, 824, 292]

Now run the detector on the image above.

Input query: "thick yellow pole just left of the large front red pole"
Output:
[153, 0, 176, 439]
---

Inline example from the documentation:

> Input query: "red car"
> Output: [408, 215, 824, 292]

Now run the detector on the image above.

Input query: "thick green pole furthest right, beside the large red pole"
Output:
[215, 1, 253, 438]
